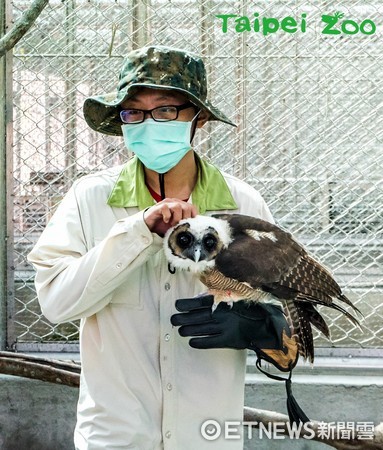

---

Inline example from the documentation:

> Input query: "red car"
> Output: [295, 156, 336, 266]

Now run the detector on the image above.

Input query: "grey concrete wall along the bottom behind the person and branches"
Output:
[0, 360, 383, 450]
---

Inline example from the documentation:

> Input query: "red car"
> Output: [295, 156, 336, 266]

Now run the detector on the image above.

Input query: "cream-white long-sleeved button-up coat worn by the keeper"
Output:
[29, 158, 272, 450]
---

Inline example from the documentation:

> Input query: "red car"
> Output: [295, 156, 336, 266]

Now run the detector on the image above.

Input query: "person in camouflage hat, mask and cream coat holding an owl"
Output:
[29, 45, 295, 450]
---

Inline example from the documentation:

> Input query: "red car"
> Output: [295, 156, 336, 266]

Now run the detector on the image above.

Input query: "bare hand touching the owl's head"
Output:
[144, 198, 198, 236]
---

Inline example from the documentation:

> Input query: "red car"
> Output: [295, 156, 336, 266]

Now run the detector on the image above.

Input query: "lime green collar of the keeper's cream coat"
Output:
[108, 156, 238, 214]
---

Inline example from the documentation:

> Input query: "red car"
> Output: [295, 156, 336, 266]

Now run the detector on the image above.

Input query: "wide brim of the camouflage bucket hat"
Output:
[83, 83, 236, 136]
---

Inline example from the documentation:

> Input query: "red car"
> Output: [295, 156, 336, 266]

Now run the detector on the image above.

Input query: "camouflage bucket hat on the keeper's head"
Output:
[84, 46, 235, 136]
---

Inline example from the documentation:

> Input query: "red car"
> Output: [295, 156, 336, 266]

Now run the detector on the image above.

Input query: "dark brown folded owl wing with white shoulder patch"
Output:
[215, 214, 360, 322]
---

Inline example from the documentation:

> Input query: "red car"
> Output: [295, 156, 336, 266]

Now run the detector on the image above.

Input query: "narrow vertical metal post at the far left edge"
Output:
[0, 0, 13, 349]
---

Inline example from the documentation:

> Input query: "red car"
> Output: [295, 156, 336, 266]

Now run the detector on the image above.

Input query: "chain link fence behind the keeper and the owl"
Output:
[8, 0, 383, 349]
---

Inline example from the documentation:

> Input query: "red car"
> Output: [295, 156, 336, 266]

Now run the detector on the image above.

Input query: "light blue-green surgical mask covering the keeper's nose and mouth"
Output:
[121, 119, 198, 173]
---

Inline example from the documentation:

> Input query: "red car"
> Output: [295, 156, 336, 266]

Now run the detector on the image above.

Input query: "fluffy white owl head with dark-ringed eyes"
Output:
[164, 216, 232, 273]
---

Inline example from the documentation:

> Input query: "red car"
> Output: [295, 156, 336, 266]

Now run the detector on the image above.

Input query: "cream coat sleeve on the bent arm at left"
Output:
[28, 183, 162, 323]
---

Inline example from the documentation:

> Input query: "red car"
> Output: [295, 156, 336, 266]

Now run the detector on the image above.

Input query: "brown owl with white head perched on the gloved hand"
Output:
[164, 214, 360, 362]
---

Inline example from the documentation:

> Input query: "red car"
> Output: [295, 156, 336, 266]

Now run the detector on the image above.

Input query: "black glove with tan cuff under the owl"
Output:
[170, 295, 298, 371]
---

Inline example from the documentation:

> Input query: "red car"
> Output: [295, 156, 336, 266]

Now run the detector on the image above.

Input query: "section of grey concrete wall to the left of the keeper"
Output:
[0, 375, 78, 450]
